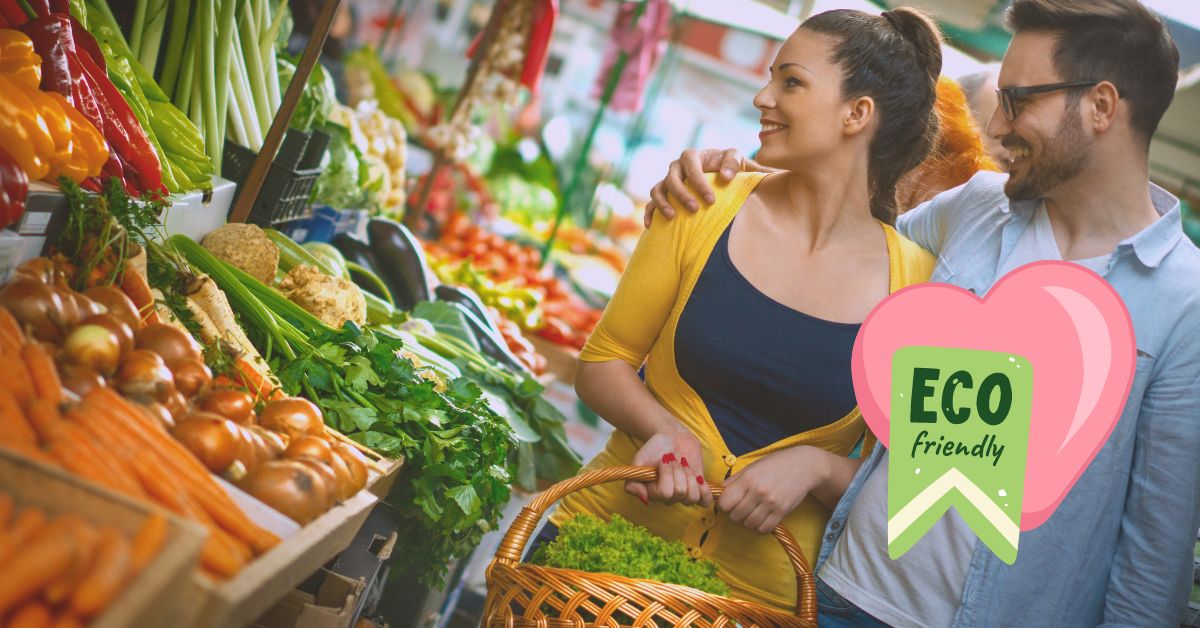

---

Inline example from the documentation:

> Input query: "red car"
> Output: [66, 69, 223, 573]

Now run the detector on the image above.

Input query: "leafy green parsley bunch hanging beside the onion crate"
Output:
[272, 323, 514, 587]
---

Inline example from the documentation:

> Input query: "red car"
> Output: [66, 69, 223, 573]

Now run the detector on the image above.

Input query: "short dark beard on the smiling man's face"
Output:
[1004, 103, 1091, 201]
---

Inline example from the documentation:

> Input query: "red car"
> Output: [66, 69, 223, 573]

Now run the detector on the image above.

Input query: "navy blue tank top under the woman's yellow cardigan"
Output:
[676, 222, 860, 455]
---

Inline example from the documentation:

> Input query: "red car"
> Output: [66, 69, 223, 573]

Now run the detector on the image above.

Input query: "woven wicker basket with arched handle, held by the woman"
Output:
[480, 467, 817, 628]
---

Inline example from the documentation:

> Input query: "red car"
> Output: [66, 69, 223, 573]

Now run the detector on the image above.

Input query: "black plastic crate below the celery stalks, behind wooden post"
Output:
[221, 128, 329, 227]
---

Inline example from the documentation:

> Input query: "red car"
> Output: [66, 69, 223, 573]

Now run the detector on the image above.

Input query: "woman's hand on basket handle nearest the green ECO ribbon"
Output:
[716, 445, 835, 534]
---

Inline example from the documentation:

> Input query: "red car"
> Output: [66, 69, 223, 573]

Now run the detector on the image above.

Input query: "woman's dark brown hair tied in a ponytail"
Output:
[800, 7, 942, 225]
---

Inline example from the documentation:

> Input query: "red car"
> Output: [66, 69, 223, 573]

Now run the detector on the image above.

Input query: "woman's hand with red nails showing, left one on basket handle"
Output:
[625, 425, 713, 508]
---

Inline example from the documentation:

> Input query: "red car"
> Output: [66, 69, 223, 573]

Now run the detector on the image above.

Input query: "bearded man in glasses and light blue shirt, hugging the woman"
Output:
[647, 0, 1200, 627]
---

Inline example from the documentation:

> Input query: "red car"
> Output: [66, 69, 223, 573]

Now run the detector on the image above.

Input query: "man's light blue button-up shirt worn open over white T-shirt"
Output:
[817, 173, 1200, 627]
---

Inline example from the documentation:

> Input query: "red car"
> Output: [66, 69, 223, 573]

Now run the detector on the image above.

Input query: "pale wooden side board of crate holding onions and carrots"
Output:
[178, 490, 379, 628]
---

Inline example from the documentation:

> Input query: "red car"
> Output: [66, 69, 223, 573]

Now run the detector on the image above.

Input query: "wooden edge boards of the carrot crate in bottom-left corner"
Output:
[0, 448, 208, 628]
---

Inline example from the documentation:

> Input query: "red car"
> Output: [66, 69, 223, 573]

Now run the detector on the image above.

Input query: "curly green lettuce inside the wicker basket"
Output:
[529, 515, 730, 596]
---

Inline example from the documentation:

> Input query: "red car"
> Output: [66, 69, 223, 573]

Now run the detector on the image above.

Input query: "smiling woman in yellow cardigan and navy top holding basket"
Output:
[549, 10, 941, 610]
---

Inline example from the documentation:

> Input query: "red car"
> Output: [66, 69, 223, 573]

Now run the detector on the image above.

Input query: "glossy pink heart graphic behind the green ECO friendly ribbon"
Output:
[852, 262, 1138, 530]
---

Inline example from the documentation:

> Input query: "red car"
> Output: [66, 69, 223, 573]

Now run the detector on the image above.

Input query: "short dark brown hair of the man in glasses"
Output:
[1007, 0, 1180, 145]
